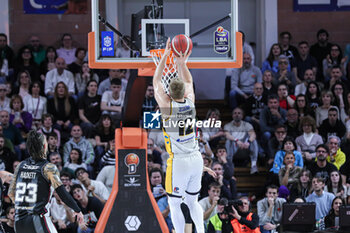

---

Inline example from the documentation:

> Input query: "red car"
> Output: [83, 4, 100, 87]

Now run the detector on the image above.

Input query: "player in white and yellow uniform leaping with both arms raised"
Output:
[153, 39, 204, 233]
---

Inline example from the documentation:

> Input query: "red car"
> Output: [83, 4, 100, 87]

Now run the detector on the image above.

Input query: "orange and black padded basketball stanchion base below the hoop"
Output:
[95, 127, 169, 233]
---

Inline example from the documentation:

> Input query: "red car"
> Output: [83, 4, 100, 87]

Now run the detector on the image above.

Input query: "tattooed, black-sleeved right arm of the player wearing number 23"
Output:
[44, 163, 85, 225]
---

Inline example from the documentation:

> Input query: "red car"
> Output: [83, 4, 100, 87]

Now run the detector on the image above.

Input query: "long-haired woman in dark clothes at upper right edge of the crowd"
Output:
[322, 44, 347, 81]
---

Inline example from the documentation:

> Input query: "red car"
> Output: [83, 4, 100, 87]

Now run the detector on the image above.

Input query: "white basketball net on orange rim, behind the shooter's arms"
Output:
[150, 49, 178, 94]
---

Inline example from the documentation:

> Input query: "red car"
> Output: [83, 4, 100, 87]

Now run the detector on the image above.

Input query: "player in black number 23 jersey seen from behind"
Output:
[8, 131, 86, 233]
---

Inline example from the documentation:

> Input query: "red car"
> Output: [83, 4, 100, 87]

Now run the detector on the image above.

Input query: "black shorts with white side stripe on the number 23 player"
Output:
[15, 214, 57, 233]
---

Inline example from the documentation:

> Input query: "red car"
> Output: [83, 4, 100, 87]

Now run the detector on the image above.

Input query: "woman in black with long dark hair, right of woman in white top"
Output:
[47, 82, 77, 139]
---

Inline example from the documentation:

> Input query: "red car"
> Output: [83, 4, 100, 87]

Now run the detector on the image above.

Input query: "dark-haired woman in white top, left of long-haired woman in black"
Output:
[23, 81, 47, 129]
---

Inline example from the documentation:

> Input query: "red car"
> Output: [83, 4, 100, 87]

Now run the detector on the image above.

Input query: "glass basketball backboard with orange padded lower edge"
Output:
[89, 0, 242, 69]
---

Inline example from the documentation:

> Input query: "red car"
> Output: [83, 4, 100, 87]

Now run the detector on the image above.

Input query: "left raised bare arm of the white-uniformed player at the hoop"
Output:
[153, 38, 171, 108]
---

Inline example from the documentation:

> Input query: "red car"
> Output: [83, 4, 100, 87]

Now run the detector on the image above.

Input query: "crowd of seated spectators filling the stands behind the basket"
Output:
[0, 29, 350, 233]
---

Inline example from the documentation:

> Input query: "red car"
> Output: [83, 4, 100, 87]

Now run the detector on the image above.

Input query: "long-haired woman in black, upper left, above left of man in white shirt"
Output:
[11, 46, 39, 84]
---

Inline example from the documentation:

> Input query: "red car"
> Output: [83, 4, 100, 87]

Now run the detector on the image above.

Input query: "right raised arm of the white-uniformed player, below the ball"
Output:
[176, 51, 195, 103]
